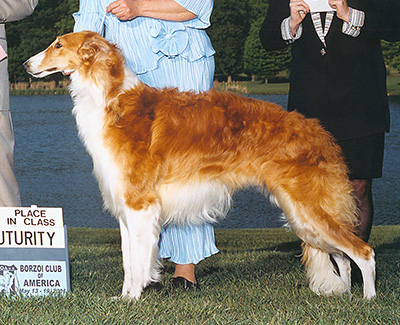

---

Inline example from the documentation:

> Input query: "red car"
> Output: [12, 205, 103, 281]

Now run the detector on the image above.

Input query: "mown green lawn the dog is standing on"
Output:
[0, 226, 400, 324]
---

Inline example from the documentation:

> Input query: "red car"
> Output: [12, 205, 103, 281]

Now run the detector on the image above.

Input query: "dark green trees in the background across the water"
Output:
[6, 0, 400, 82]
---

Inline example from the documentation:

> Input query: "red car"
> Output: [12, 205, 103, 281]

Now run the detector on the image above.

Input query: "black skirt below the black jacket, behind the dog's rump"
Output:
[338, 133, 385, 180]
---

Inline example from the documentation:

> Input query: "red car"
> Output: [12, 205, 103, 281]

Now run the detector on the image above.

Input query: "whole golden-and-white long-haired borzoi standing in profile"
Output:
[25, 32, 375, 299]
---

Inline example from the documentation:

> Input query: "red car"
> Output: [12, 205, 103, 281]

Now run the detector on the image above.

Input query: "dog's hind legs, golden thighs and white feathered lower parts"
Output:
[275, 185, 376, 299]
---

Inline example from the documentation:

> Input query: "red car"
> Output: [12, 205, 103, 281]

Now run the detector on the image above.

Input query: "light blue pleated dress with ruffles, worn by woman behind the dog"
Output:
[74, 0, 218, 264]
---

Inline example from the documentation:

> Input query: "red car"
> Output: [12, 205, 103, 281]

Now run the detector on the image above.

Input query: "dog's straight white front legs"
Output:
[120, 206, 161, 299]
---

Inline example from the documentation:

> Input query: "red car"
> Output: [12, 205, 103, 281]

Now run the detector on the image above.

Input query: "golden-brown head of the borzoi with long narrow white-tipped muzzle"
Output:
[24, 31, 123, 78]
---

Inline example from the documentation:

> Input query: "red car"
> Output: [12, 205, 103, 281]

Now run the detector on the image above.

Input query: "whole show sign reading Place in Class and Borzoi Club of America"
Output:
[0, 205, 70, 296]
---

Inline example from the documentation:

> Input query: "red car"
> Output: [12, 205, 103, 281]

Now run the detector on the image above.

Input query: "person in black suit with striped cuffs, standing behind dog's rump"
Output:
[260, 0, 400, 241]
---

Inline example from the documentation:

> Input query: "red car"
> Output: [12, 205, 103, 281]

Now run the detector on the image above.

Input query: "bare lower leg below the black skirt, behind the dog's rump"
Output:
[352, 179, 374, 242]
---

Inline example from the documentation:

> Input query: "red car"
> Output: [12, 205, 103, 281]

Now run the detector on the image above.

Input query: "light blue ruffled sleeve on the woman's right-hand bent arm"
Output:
[175, 0, 214, 29]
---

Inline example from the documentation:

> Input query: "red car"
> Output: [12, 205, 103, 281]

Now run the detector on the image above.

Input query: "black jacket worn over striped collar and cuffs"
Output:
[260, 0, 400, 140]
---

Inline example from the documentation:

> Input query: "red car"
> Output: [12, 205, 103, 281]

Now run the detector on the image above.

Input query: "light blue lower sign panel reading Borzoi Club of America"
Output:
[0, 261, 68, 296]
